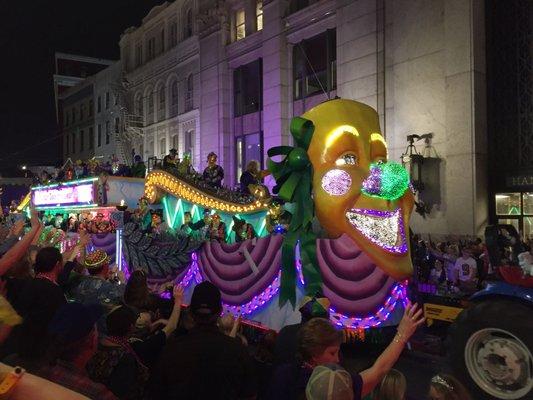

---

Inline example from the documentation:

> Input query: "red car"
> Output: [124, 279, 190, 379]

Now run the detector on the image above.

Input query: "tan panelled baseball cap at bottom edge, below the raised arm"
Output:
[305, 364, 354, 400]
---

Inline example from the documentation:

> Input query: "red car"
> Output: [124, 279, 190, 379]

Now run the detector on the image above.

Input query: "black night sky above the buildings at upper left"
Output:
[0, 0, 164, 176]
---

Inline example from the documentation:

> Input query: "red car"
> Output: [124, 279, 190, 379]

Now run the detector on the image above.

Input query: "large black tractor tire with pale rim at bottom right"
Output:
[448, 299, 533, 400]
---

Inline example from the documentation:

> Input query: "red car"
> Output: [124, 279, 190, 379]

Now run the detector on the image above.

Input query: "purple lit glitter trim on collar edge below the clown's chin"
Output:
[329, 282, 409, 329]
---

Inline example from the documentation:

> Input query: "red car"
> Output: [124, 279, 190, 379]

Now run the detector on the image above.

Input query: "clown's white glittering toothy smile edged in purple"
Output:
[346, 208, 407, 254]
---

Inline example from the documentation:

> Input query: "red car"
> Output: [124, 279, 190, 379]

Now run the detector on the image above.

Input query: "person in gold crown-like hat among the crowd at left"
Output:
[66, 250, 125, 308]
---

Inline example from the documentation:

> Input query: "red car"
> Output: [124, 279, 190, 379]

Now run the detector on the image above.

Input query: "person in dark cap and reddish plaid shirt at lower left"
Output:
[37, 303, 116, 400]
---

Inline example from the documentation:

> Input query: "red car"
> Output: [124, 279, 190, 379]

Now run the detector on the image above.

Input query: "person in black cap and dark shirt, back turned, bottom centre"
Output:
[149, 281, 256, 400]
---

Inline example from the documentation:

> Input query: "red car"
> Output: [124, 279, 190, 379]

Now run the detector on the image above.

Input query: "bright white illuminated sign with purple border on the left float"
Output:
[32, 183, 94, 207]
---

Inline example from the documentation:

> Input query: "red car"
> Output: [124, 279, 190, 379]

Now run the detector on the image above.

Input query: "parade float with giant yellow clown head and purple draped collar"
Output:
[131, 99, 413, 329]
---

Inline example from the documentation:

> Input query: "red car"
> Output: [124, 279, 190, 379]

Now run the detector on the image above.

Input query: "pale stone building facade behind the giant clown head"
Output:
[114, 0, 488, 235]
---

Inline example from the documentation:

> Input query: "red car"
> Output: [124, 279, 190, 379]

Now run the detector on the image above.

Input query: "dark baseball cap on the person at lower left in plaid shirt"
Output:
[48, 303, 103, 343]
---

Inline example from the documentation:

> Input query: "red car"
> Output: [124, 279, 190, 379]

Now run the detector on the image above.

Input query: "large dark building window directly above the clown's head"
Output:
[293, 29, 337, 100]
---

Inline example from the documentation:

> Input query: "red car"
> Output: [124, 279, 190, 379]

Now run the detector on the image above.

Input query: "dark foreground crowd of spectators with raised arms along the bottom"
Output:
[0, 213, 469, 400]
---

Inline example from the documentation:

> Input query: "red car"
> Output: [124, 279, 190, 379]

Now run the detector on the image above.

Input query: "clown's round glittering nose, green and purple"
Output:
[362, 162, 409, 201]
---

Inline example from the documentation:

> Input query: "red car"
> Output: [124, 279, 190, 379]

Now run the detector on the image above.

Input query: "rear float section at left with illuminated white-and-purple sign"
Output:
[26, 175, 144, 268]
